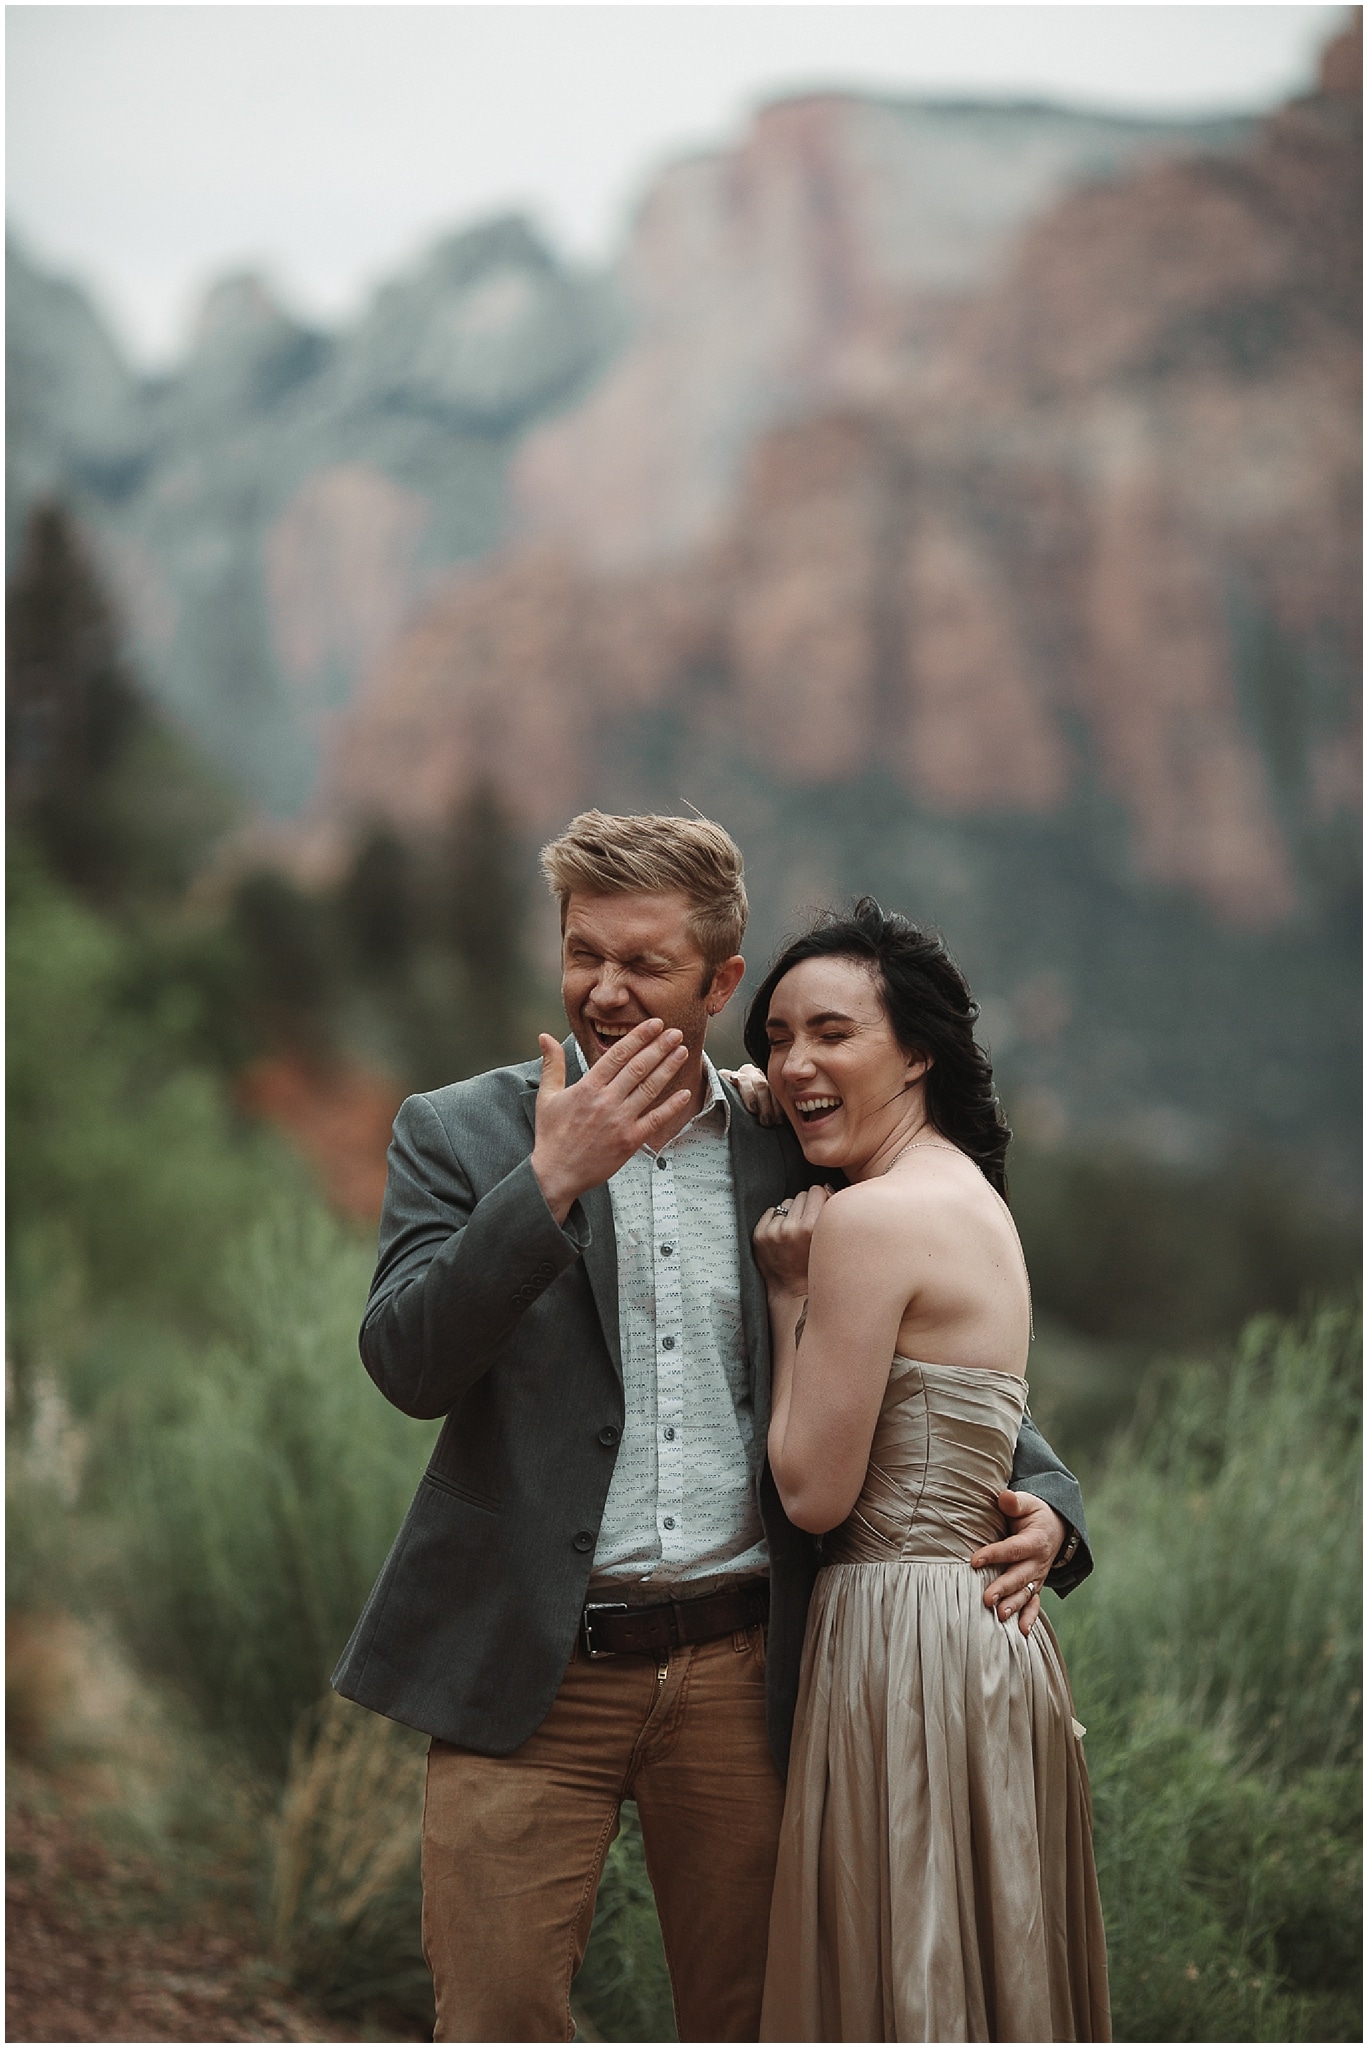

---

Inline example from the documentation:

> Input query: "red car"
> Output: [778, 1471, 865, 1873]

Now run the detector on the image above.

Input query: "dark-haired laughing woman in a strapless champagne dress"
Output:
[745, 899, 1110, 2042]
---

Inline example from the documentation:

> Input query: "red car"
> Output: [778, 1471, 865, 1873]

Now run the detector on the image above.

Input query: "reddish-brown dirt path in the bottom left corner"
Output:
[6, 1792, 374, 2042]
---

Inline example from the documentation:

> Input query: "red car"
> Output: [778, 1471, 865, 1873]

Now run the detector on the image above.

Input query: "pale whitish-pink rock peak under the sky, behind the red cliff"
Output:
[512, 92, 1247, 567]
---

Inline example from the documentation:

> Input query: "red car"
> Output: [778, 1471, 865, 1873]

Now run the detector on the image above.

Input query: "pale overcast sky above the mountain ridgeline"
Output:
[6, 4, 1343, 365]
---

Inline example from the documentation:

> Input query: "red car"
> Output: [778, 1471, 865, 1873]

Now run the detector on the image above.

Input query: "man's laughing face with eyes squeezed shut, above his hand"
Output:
[561, 891, 741, 1065]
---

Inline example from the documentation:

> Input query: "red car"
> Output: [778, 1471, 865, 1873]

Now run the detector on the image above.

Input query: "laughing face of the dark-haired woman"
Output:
[766, 956, 930, 1178]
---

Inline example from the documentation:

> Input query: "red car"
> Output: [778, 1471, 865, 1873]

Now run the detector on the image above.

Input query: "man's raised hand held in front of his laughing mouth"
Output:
[532, 1018, 692, 1223]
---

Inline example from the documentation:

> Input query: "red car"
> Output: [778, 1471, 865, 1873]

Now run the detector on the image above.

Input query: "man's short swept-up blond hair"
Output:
[541, 811, 747, 969]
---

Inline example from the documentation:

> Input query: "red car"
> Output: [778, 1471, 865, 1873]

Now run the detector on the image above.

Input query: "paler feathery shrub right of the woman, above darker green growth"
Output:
[1059, 1307, 1362, 1772]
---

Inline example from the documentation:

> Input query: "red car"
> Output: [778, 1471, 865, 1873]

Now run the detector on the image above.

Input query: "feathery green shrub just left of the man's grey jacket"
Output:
[111, 1204, 434, 1776]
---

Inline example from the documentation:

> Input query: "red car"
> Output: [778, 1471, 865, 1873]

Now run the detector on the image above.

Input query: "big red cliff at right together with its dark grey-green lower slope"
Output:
[311, 36, 1360, 1171]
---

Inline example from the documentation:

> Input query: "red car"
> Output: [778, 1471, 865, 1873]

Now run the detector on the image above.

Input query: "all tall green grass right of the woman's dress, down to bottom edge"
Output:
[1057, 1309, 1362, 2040]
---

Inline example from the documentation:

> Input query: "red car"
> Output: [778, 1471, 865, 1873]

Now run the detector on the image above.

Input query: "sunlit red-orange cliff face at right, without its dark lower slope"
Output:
[317, 55, 1360, 928]
